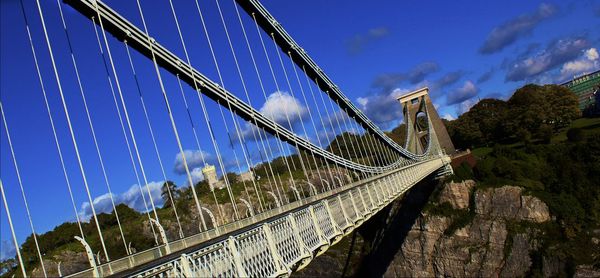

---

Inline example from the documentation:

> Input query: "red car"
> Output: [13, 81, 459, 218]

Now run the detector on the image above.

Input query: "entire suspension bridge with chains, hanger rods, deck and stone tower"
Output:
[0, 0, 454, 277]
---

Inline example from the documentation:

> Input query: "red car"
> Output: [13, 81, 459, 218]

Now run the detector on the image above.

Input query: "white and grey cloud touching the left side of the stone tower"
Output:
[356, 89, 409, 129]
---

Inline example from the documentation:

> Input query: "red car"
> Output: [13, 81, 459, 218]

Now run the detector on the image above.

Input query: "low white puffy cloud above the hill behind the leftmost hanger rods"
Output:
[78, 181, 163, 221]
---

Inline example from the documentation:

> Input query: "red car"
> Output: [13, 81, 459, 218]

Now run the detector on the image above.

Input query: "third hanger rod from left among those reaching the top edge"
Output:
[56, 0, 129, 255]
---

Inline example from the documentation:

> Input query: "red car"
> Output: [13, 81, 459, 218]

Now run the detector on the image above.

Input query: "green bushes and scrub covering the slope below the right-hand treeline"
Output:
[468, 133, 600, 268]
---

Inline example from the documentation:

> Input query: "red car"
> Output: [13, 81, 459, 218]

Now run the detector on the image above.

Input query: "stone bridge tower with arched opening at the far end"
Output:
[398, 87, 455, 155]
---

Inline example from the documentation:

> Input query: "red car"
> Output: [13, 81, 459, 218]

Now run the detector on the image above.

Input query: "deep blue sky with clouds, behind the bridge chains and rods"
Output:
[0, 0, 600, 260]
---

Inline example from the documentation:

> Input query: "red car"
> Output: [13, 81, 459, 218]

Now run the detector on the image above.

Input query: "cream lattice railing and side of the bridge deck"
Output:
[70, 157, 449, 277]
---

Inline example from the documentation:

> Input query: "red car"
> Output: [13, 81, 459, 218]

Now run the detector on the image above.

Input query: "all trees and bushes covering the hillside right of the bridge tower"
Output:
[432, 85, 600, 276]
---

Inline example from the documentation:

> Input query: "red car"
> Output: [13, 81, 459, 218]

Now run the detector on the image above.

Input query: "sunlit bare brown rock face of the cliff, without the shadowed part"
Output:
[384, 181, 552, 277]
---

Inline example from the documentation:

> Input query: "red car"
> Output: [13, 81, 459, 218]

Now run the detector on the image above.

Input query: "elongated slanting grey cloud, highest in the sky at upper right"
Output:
[479, 3, 558, 54]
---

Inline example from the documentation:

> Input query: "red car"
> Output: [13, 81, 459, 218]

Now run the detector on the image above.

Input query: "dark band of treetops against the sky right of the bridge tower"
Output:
[446, 84, 581, 149]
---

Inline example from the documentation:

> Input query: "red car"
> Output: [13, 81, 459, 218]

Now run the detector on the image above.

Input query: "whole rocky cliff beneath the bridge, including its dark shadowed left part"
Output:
[293, 180, 600, 277]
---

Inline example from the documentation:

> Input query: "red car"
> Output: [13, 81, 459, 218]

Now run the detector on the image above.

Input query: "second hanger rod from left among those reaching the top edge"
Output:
[35, 0, 112, 262]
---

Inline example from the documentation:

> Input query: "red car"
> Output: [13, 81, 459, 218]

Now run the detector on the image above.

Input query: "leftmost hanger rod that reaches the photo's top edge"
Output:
[17, 0, 85, 239]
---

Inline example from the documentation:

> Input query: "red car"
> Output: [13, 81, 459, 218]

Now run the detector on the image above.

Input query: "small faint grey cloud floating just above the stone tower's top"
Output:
[372, 62, 440, 91]
